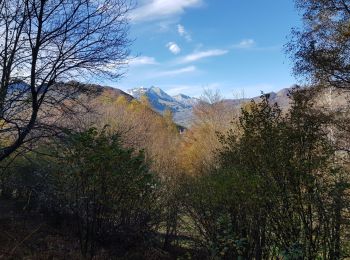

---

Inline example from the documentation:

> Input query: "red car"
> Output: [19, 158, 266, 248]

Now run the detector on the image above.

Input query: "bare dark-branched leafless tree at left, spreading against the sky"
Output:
[0, 0, 129, 161]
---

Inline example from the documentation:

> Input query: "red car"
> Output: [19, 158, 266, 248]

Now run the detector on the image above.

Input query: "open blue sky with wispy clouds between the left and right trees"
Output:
[107, 0, 301, 98]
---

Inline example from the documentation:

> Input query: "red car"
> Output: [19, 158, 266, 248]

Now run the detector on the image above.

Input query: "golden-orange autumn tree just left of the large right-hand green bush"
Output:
[180, 90, 238, 175]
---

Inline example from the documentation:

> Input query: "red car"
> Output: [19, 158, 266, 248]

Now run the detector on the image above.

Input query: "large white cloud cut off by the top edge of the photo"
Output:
[130, 0, 203, 22]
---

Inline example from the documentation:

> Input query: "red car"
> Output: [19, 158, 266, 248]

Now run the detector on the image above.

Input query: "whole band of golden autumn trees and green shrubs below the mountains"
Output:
[1, 85, 350, 259]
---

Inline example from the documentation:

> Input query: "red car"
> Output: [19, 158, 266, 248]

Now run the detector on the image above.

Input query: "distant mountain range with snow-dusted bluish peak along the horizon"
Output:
[8, 81, 350, 128]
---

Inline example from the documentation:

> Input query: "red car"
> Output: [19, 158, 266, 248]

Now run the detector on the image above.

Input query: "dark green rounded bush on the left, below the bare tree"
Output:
[0, 129, 160, 256]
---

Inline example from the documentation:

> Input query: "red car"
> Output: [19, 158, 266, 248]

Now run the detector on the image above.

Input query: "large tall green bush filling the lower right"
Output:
[179, 90, 350, 259]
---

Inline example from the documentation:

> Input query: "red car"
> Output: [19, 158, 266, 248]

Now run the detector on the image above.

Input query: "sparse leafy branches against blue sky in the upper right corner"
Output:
[287, 0, 350, 89]
